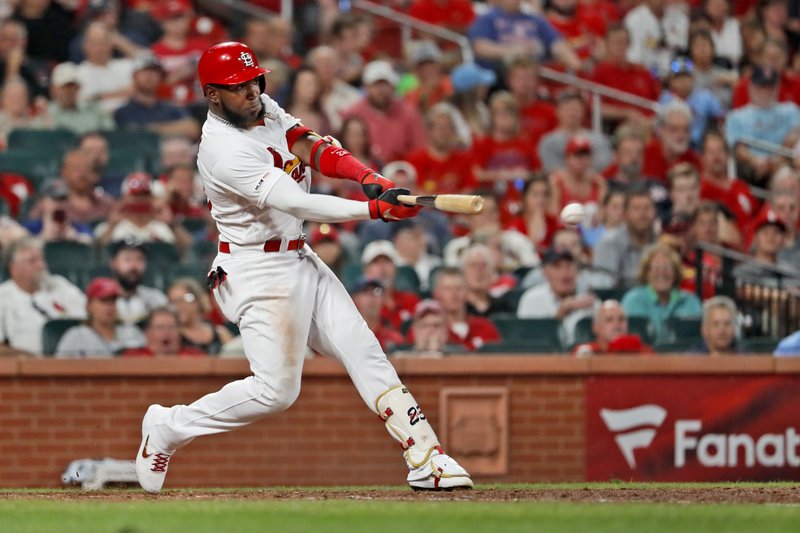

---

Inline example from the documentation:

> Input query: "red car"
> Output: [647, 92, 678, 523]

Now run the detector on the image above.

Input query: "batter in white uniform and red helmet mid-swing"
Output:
[136, 42, 472, 492]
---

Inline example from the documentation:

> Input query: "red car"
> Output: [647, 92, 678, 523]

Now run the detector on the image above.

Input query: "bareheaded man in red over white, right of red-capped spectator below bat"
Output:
[432, 267, 501, 351]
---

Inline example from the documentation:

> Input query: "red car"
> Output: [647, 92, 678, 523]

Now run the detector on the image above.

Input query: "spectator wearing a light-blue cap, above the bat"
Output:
[450, 63, 497, 141]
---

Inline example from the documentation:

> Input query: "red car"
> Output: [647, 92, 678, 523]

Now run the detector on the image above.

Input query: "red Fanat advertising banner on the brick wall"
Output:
[586, 375, 800, 481]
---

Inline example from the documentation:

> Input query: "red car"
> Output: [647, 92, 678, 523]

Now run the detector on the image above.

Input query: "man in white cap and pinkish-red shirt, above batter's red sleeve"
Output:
[343, 61, 428, 161]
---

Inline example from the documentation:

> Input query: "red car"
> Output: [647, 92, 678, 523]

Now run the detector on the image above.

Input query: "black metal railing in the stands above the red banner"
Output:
[695, 243, 800, 338]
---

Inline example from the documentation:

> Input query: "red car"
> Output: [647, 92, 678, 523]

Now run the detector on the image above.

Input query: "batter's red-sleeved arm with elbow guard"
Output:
[286, 124, 395, 200]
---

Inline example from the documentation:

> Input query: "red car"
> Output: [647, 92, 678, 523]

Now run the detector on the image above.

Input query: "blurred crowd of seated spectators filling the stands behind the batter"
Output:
[0, 0, 800, 358]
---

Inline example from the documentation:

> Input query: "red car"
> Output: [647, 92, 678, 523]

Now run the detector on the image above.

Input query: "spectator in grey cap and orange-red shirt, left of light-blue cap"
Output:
[404, 41, 453, 114]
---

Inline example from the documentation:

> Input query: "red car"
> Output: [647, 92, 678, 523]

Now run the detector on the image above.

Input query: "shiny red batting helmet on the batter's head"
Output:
[197, 42, 270, 90]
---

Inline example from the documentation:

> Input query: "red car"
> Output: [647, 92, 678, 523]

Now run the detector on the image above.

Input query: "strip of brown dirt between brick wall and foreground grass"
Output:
[0, 485, 800, 504]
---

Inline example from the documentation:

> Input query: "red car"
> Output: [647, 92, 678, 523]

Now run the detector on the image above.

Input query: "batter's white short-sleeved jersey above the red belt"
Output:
[197, 94, 311, 245]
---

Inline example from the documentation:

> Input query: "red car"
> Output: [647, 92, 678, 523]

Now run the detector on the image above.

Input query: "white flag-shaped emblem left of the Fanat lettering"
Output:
[600, 404, 667, 470]
